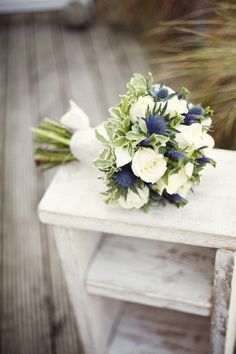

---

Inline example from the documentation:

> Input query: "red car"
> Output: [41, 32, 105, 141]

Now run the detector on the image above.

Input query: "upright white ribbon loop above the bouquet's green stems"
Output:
[60, 100, 90, 131]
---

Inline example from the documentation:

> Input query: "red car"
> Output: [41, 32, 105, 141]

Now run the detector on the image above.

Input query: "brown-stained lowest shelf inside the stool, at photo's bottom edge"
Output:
[107, 304, 209, 354]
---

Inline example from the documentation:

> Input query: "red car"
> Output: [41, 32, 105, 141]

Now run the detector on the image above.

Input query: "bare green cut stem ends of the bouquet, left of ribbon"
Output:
[30, 118, 76, 171]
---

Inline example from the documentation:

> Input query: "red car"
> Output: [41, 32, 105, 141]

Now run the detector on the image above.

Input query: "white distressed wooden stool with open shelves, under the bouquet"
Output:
[39, 150, 236, 354]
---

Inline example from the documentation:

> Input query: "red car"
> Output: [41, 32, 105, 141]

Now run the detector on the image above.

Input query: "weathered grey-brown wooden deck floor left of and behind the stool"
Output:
[0, 13, 148, 354]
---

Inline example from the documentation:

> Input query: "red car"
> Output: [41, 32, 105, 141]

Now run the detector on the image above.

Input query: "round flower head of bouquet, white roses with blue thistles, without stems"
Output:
[95, 74, 215, 210]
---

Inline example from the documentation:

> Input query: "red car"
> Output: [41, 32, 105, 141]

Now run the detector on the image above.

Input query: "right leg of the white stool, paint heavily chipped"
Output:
[210, 249, 236, 354]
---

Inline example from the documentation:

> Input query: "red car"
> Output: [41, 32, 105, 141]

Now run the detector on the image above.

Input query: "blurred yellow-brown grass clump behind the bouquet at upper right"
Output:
[147, 2, 236, 149]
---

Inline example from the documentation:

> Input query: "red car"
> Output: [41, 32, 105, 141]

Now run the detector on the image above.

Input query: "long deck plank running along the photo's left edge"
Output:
[1, 16, 51, 354]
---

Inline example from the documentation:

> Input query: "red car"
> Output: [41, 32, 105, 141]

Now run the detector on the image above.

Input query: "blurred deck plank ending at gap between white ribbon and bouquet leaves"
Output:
[62, 19, 107, 126]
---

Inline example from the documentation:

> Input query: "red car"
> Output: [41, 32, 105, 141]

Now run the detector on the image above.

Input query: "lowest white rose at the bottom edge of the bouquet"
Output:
[118, 186, 149, 209]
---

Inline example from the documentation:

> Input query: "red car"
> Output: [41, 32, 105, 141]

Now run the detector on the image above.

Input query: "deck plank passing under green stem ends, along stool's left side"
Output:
[32, 14, 81, 354]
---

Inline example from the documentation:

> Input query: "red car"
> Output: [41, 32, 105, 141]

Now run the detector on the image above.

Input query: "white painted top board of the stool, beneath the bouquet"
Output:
[39, 149, 236, 248]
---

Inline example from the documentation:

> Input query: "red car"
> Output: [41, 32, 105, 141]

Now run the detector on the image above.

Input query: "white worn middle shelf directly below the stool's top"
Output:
[86, 235, 215, 316]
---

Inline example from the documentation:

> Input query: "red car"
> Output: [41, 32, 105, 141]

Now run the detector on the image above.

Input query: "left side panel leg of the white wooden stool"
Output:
[51, 227, 122, 354]
